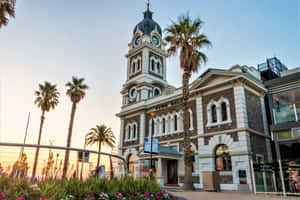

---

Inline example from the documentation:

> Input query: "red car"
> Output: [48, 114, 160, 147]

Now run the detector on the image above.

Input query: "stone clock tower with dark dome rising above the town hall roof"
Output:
[121, 6, 168, 106]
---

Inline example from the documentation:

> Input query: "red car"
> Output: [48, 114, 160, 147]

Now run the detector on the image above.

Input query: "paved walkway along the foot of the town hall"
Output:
[165, 188, 300, 200]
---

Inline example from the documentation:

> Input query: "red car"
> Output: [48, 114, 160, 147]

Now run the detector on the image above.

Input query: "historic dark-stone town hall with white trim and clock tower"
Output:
[117, 9, 272, 190]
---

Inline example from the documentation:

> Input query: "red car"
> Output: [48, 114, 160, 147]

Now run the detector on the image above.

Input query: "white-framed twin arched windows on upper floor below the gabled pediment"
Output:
[206, 97, 231, 127]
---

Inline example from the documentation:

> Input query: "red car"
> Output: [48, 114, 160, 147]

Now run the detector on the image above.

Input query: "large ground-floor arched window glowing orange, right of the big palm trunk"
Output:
[216, 144, 232, 171]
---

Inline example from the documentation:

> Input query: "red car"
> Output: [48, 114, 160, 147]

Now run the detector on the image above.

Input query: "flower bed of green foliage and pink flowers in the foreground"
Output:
[0, 177, 176, 200]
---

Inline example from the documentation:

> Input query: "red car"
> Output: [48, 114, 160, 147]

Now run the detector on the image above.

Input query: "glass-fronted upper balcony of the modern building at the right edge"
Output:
[273, 103, 300, 125]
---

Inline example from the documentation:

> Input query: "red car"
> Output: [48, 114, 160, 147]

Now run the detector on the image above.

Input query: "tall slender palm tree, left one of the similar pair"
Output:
[32, 81, 59, 178]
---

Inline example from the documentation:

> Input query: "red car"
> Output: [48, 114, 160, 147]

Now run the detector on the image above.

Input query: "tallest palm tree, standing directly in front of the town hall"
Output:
[165, 15, 211, 190]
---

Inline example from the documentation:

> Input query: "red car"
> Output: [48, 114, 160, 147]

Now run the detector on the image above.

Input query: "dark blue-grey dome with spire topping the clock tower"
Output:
[133, 7, 161, 35]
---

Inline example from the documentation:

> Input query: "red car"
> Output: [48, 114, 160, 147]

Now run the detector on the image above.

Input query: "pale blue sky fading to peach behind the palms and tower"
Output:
[0, 0, 300, 151]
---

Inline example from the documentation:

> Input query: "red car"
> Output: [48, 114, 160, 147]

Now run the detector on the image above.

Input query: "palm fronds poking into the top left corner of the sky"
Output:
[0, 0, 16, 28]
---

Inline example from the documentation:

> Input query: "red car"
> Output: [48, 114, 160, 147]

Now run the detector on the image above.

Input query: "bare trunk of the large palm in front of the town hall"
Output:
[182, 71, 194, 190]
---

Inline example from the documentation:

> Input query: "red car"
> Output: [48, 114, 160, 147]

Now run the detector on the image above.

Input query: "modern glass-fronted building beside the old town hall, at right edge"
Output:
[258, 58, 300, 193]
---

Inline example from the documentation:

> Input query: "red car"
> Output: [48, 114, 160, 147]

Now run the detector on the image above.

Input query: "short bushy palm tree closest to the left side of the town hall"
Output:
[87, 124, 116, 170]
